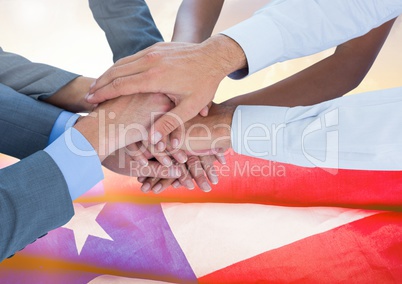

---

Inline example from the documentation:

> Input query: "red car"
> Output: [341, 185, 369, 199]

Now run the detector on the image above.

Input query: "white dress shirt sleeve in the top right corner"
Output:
[222, 0, 402, 78]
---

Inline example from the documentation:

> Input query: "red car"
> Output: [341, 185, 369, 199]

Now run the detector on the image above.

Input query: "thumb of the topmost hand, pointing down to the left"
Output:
[149, 99, 202, 144]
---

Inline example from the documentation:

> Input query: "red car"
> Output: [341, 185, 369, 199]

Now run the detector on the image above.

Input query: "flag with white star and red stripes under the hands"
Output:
[0, 154, 402, 283]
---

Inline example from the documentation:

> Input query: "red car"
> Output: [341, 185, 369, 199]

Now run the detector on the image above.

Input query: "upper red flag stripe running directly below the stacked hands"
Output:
[99, 152, 402, 209]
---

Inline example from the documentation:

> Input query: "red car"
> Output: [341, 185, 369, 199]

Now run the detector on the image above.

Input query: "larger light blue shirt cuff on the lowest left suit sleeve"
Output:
[45, 128, 103, 200]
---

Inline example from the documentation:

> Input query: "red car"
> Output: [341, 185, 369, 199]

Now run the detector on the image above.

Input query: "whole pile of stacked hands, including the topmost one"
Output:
[76, 36, 245, 193]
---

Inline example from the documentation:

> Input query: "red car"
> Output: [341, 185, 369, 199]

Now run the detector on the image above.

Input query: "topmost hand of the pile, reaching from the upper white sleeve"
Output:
[87, 35, 246, 148]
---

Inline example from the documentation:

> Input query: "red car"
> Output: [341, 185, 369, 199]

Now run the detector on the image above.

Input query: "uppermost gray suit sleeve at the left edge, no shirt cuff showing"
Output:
[0, 48, 79, 99]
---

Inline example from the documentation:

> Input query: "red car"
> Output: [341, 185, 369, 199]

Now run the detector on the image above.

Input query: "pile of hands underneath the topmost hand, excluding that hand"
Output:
[75, 94, 233, 193]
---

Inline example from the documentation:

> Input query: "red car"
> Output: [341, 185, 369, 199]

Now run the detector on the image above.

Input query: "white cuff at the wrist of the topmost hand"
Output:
[221, 13, 284, 79]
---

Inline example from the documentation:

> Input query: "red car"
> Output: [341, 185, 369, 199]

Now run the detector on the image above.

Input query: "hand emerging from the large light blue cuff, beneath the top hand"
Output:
[74, 94, 172, 162]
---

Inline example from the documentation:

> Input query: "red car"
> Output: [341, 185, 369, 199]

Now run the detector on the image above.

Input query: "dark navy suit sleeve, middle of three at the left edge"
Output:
[0, 84, 62, 159]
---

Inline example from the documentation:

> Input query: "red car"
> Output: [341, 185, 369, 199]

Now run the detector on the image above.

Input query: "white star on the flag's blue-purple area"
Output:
[62, 203, 113, 255]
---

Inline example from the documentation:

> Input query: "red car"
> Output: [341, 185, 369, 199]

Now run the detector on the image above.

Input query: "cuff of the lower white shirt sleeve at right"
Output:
[231, 106, 289, 163]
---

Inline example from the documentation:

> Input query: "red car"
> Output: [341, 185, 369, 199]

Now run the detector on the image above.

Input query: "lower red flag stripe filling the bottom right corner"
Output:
[200, 213, 402, 283]
